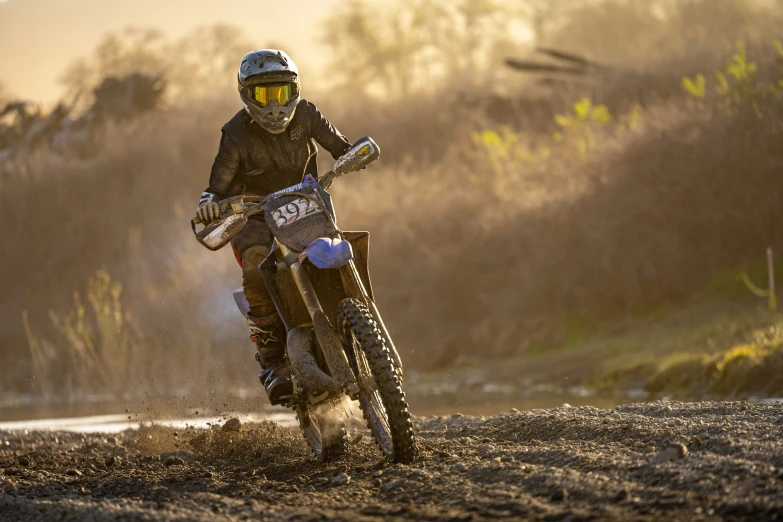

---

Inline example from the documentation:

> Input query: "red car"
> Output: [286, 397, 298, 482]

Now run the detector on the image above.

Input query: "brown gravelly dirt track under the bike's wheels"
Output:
[0, 402, 783, 521]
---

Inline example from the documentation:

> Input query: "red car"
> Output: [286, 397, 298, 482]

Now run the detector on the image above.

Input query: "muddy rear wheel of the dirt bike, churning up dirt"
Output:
[294, 400, 348, 462]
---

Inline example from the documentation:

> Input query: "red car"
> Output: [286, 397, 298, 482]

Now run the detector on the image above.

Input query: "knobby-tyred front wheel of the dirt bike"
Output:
[336, 299, 417, 464]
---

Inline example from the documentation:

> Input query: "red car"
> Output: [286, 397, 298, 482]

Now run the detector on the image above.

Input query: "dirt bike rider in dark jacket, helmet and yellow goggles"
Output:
[198, 49, 350, 404]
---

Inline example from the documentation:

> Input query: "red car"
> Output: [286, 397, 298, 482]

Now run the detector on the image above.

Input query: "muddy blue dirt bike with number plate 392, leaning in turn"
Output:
[191, 138, 417, 463]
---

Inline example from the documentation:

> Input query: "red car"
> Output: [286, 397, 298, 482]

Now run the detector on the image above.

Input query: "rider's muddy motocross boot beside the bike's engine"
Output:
[247, 313, 294, 405]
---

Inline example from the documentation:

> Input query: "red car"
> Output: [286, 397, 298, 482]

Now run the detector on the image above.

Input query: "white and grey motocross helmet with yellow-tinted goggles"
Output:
[237, 49, 301, 134]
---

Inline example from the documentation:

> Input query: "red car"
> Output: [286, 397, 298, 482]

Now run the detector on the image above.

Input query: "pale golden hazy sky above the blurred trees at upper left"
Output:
[0, 0, 336, 102]
